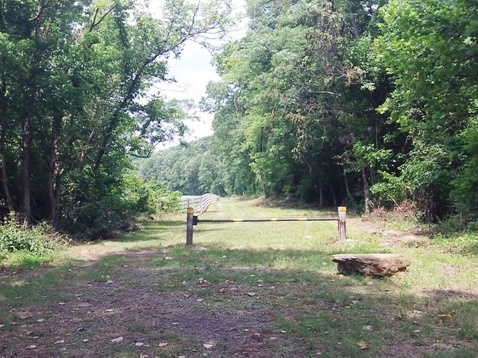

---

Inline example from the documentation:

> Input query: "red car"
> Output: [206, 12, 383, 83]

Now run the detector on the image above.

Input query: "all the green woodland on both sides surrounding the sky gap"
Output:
[0, 0, 478, 239]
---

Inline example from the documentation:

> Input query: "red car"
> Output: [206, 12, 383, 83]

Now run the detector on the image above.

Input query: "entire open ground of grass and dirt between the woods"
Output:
[0, 199, 478, 358]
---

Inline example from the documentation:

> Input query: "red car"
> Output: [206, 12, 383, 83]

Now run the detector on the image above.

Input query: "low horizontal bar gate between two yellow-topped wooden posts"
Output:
[186, 206, 347, 246]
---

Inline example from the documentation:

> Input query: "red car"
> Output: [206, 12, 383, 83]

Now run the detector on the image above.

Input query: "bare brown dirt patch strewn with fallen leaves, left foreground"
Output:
[0, 251, 298, 358]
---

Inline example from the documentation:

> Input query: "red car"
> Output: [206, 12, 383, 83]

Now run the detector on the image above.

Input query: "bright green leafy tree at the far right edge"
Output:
[376, 0, 478, 221]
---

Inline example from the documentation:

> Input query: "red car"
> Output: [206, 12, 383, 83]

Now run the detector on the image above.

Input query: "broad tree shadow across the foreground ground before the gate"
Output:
[0, 245, 478, 358]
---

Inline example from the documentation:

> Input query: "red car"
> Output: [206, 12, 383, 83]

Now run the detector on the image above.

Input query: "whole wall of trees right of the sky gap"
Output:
[142, 0, 478, 224]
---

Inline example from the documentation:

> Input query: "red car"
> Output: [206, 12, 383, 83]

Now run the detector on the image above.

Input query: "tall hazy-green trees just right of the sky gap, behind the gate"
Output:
[205, 0, 390, 210]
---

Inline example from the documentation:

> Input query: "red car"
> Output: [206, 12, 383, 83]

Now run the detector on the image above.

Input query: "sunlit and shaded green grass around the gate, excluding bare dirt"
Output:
[0, 199, 478, 358]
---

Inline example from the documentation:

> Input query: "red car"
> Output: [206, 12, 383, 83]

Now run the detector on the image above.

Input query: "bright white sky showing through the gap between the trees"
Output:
[152, 0, 247, 147]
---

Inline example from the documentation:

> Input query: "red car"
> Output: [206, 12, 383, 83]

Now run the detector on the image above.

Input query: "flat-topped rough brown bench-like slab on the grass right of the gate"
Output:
[332, 254, 411, 277]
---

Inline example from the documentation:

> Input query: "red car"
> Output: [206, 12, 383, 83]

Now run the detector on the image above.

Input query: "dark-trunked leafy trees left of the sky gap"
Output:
[0, 0, 231, 241]
